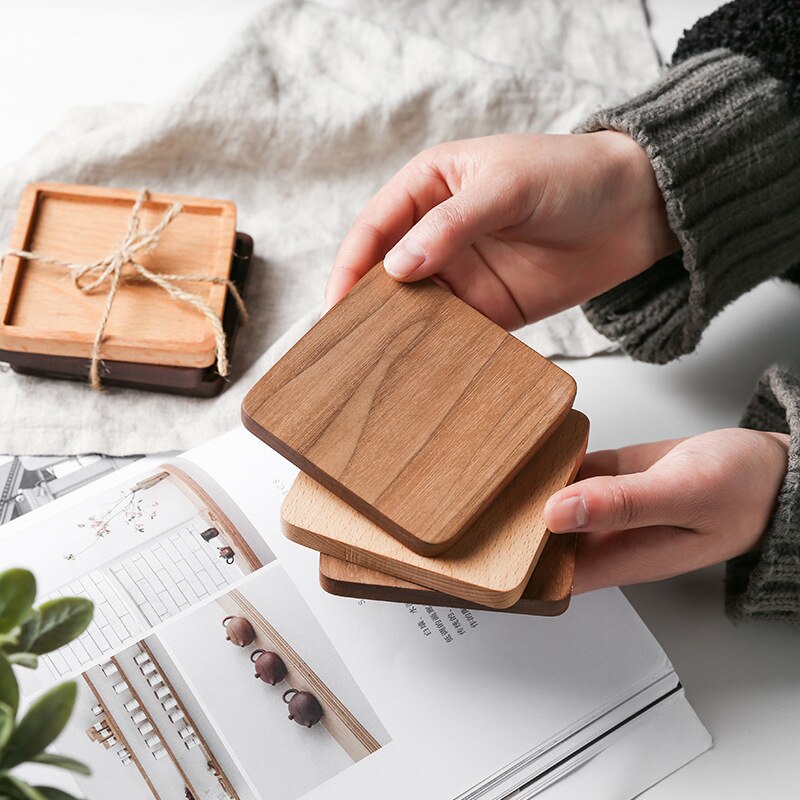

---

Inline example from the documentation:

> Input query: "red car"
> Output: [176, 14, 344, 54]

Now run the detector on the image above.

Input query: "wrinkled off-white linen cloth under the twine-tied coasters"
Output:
[0, 0, 658, 455]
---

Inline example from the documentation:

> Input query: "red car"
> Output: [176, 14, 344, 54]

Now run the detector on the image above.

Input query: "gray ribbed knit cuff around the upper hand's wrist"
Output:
[578, 49, 800, 363]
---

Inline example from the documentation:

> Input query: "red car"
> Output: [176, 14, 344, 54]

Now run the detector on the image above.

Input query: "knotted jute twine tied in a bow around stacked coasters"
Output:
[0, 189, 249, 390]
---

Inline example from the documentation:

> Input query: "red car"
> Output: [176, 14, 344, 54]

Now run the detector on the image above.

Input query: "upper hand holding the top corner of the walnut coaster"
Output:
[325, 131, 678, 329]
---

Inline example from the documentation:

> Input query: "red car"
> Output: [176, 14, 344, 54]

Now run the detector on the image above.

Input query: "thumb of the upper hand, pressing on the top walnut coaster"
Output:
[383, 182, 523, 281]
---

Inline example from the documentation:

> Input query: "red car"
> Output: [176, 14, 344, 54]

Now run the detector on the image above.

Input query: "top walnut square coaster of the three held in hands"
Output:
[242, 264, 575, 556]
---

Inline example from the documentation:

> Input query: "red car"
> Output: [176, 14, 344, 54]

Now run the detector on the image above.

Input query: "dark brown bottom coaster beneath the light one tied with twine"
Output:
[0, 232, 253, 397]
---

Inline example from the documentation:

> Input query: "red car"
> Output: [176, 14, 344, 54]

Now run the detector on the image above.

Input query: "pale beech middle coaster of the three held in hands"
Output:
[281, 411, 589, 609]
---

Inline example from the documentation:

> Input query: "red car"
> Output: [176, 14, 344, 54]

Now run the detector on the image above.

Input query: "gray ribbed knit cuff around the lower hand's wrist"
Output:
[725, 367, 800, 622]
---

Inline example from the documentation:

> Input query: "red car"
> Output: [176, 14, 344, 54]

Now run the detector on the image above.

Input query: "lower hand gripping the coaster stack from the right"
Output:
[544, 428, 789, 594]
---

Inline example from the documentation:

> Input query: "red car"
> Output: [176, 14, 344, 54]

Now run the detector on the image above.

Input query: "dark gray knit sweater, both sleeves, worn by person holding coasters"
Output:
[581, 0, 800, 621]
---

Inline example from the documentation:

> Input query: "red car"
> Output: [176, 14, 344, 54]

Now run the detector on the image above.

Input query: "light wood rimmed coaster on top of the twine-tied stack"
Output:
[0, 183, 236, 367]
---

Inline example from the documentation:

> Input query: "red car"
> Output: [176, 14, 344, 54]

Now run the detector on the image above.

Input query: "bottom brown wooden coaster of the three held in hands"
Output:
[319, 533, 577, 617]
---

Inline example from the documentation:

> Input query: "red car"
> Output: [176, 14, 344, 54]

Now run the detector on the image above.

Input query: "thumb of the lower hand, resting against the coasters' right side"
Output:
[544, 467, 701, 533]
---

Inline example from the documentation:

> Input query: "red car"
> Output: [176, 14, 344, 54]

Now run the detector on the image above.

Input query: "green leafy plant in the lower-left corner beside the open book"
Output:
[0, 569, 94, 800]
